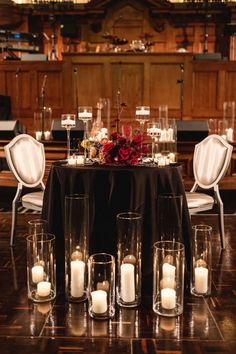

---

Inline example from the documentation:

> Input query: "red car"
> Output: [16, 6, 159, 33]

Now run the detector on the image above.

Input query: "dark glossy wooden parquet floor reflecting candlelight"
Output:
[0, 212, 236, 354]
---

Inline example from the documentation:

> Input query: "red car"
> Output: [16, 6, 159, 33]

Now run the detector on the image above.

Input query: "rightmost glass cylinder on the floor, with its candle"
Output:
[190, 225, 212, 296]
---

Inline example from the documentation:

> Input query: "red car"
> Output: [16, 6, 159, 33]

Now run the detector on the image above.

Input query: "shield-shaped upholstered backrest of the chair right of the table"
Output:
[193, 134, 233, 189]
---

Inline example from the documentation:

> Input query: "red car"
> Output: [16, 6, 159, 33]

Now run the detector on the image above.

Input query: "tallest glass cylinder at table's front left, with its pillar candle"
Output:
[65, 194, 89, 302]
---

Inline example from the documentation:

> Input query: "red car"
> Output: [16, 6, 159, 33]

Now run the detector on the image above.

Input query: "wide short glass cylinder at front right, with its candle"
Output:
[153, 241, 185, 317]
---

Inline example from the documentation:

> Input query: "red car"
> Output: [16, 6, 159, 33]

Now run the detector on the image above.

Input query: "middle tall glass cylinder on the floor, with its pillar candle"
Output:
[116, 212, 142, 307]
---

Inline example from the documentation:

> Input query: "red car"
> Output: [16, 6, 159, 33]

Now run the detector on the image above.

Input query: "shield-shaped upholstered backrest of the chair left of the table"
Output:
[4, 134, 45, 188]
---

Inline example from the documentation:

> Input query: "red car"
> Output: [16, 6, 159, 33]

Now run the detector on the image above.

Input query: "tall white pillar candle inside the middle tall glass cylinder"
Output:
[120, 263, 135, 302]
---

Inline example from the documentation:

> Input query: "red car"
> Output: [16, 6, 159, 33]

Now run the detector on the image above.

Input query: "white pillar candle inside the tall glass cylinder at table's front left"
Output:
[70, 260, 85, 297]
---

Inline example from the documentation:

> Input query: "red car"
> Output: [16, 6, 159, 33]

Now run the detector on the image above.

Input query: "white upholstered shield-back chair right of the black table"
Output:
[186, 134, 233, 249]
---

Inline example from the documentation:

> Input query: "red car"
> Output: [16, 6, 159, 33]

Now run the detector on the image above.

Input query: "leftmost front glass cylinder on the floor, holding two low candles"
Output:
[27, 233, 56, 303]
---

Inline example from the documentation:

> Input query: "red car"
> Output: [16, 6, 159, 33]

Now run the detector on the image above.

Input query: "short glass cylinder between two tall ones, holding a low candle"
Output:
[88, 253, 115, 320]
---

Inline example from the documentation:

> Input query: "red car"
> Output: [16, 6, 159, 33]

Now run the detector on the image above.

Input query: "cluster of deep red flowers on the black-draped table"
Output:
[101, 132, 142, 165]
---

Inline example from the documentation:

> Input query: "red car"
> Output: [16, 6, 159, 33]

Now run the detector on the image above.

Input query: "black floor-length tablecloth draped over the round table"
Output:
[42, 162, 191, 292]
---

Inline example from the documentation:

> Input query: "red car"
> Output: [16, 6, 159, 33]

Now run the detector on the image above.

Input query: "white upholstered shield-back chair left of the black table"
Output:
[4, 134, 45, 246]
